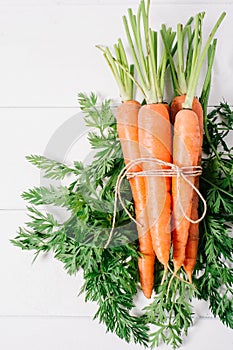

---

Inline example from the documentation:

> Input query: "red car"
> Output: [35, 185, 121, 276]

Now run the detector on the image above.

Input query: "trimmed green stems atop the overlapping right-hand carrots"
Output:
[161, 12, 226, 108]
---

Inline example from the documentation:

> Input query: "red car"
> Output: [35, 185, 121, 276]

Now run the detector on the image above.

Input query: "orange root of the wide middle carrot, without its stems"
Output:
[138, 103, 172, 276]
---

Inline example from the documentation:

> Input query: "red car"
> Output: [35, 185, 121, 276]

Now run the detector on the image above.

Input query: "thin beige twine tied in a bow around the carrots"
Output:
[104, 158, 207, 248]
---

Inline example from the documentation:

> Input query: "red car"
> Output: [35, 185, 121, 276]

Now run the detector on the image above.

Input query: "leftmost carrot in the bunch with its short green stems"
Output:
[97, 39, 155, 298]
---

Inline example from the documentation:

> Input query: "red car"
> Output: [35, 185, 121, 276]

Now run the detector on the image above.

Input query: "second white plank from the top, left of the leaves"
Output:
[0, 108, 92, 209]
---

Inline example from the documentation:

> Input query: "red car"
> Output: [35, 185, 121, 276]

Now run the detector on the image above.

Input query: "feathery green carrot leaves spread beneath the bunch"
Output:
[12, 94, 233, 348]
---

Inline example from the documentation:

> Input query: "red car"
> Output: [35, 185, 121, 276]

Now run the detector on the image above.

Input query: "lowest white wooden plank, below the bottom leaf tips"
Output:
[0, 317, 233, 350]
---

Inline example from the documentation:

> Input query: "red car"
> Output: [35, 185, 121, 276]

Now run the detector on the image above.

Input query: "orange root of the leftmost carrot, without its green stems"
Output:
[117, 100, 155, 298]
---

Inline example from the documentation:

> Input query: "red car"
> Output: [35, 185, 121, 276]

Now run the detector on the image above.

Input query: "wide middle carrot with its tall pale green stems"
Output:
[123, 0, 175, 278]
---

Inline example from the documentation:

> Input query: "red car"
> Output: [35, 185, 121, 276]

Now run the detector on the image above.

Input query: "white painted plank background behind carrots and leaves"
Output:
[0, 0, 233, 350]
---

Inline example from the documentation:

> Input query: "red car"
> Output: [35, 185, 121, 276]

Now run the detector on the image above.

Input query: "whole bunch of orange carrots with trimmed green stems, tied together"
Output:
[99, 0, 225, 298]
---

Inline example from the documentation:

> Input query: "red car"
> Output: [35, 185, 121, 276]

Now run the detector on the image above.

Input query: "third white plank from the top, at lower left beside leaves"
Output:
[0, 211, 96, 316]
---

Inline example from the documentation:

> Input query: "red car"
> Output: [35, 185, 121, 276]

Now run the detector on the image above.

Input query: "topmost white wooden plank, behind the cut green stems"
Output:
[0, 2, 233, 106]
